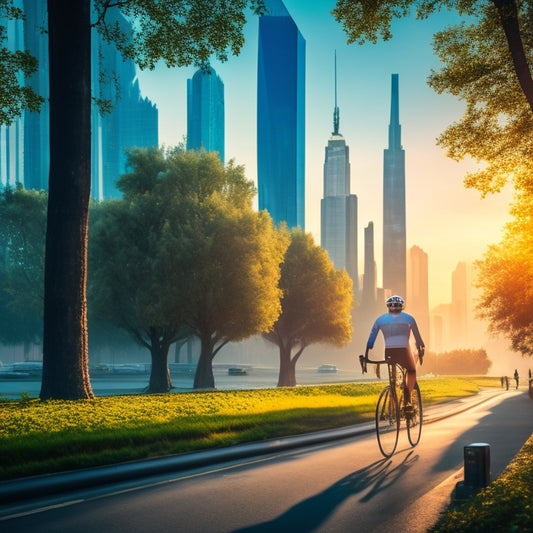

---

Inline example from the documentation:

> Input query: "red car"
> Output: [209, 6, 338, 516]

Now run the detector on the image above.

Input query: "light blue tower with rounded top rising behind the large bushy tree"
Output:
[187, 67, 224, 162]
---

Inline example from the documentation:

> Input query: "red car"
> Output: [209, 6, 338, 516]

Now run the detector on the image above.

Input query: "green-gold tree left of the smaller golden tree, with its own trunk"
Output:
[192, 204, 287, 389]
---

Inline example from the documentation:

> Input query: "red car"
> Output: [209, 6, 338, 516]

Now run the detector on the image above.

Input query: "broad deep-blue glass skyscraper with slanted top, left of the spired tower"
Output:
[257, 0, 305, 229]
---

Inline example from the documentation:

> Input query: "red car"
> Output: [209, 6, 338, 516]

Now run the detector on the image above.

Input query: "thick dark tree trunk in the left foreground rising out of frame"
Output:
[40, 0, 93, 400]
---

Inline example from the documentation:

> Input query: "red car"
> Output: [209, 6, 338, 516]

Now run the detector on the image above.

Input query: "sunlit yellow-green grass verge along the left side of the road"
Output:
[0, 377, 500, 480]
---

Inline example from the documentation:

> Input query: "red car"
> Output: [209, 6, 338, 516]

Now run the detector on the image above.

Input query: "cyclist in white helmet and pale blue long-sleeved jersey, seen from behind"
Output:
[365, 296, 425, 406]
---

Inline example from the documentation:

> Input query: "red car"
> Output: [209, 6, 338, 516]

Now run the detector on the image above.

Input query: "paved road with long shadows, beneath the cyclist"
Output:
[0, 390, 533, 533]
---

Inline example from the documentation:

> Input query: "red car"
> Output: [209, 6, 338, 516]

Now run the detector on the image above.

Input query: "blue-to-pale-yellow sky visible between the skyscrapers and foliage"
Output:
[135, 0, 512, 308]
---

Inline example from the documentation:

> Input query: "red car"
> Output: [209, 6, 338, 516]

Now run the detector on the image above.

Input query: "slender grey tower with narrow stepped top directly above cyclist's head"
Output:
[383, 74, 406, 297]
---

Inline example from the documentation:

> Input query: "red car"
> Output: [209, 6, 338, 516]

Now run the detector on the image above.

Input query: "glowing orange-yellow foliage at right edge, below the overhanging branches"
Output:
[476, 197, 533, 356]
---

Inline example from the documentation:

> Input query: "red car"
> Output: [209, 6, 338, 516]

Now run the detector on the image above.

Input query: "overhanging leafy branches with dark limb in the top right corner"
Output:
[333, 0, 533, 195]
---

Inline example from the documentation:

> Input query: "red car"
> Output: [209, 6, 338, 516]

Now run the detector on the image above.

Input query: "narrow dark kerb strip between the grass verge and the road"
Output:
[0, 389, 506, 508]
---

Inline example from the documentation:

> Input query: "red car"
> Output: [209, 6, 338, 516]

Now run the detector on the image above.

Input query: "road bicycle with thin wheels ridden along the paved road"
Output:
[359, 353, 422, 458]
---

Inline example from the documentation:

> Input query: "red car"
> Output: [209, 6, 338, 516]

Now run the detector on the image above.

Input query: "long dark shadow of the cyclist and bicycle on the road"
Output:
[233, 451, 418, 533]
